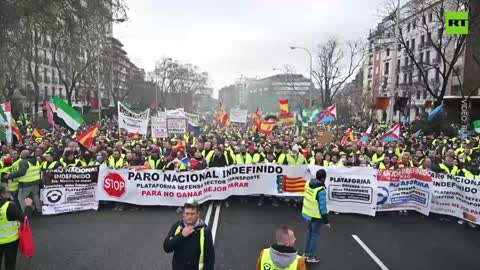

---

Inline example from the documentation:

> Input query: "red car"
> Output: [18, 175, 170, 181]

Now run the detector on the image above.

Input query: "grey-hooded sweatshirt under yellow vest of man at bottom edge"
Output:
[256, 245, 307, 270]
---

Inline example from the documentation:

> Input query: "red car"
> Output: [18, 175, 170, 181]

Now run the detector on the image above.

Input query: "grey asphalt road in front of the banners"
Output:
[25, 200, 480, 270]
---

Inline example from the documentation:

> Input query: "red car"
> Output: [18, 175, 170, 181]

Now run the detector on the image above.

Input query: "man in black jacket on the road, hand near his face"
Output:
[163, 201, 215, 270]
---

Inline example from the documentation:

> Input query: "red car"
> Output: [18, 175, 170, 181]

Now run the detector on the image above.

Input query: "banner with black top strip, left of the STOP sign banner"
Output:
[40, 166, 99, 215]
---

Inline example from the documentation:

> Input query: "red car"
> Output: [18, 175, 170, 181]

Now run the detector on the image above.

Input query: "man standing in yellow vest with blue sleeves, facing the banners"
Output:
[302, 169, 330, 263]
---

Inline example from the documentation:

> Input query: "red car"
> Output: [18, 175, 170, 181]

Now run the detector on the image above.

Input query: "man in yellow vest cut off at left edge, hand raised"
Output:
[0, 183, 33, 270]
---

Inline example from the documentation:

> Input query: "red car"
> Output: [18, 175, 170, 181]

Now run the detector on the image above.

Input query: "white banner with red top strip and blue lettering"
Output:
[377, 167, 433, 215]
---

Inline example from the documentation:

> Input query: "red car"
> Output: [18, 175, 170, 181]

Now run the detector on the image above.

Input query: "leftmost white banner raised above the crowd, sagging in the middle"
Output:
[118, 101, 150, 135]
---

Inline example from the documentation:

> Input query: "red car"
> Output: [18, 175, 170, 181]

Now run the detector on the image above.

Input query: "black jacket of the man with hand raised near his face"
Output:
[163, 220, 215, 270]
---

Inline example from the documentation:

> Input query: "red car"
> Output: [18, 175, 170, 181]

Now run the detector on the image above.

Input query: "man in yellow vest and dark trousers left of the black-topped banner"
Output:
[3, 150, 42, 213]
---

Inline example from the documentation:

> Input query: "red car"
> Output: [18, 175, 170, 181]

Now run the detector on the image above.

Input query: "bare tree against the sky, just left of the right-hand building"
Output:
[312, 37, 365, 107]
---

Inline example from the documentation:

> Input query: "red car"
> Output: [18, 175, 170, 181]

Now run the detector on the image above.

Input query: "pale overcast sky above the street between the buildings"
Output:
[114, 0, 385, 97]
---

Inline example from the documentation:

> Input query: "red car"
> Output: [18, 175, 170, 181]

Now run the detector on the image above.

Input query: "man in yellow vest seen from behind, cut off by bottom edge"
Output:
[255, 226, 307, 270]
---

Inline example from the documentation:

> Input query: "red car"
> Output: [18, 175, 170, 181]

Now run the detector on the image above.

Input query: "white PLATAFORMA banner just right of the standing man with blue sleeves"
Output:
[318, 165, 377, 216]
